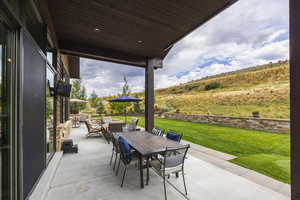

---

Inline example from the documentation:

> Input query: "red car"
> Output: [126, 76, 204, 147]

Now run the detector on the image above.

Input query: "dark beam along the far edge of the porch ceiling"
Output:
[59, 41, 147, 67]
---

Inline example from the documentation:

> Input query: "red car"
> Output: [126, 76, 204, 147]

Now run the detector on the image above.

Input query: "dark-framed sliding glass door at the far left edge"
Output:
[0, 19, 12, 200]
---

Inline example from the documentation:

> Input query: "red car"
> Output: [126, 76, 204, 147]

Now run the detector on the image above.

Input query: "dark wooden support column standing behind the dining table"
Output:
[145, 58, 162, 132]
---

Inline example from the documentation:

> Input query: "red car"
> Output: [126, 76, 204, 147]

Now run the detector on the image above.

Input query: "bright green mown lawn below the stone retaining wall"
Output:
[111, 117, 290, 183]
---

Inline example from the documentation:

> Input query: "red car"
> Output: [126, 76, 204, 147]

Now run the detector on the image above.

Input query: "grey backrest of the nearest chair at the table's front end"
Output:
[163, 144, 190, 170]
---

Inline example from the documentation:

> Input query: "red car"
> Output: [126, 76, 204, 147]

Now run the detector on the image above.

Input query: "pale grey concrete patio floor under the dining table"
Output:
[47, 126, 289, 200]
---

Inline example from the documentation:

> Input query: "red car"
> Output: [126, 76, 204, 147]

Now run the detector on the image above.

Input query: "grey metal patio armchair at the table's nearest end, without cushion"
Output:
[150, 144, 190, 200]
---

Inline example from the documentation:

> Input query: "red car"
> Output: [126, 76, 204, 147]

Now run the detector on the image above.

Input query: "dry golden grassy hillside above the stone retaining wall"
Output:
[99, 62, 290, 119]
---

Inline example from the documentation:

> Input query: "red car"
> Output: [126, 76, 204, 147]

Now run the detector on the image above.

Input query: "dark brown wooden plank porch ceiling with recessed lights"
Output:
[47, 0, 237, 66]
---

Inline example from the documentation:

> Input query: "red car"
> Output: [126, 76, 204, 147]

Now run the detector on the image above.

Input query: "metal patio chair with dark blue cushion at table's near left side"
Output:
[117, 136, 142, 187]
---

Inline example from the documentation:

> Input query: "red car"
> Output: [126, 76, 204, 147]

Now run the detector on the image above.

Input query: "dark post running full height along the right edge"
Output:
[290, 0, 300, 200]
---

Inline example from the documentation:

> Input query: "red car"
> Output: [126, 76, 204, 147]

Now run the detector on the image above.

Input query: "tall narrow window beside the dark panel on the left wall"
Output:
[46, 68, 55, 158]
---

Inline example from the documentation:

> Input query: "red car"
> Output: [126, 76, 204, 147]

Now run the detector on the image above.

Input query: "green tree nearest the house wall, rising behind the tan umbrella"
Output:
[70, 79, 86, 112]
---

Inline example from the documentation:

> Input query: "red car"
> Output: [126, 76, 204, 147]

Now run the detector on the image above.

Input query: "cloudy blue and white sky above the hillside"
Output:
[80, 0, 289, 96]
